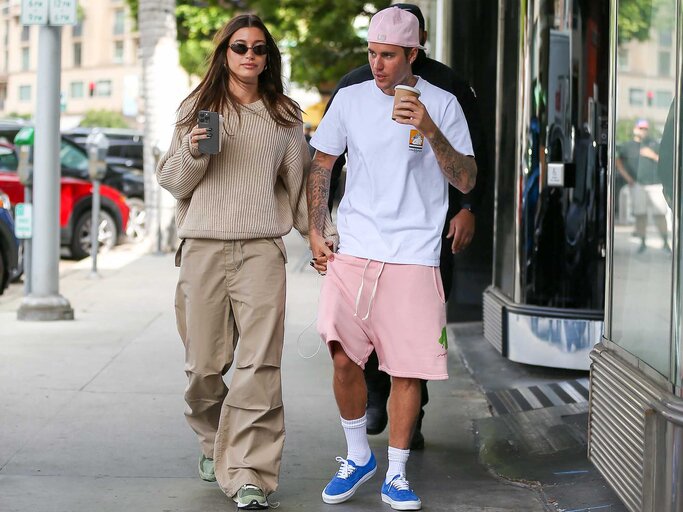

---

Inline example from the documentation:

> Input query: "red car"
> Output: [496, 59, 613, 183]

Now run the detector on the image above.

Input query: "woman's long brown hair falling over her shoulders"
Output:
[177, 14, 301, 128]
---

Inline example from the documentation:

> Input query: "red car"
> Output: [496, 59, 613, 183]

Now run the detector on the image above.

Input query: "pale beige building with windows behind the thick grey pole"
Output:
[0, 0, 142, 126]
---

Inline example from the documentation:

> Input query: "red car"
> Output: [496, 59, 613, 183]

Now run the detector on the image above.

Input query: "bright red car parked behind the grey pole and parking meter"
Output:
[0, 143, 129, 259]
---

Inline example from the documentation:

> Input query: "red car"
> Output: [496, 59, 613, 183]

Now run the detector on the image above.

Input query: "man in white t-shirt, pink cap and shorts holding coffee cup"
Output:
[307, 7, 476, 510]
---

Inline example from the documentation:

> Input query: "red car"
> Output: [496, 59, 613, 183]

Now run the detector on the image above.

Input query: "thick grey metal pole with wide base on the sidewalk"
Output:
[17, 25, 74, 320]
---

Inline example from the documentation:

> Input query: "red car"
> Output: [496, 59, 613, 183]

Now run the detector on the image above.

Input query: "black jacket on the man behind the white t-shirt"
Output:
[325, 50, 487, 220]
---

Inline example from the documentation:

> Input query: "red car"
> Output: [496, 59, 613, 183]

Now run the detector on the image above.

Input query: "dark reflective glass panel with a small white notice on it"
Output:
[516, 0, 608, 312]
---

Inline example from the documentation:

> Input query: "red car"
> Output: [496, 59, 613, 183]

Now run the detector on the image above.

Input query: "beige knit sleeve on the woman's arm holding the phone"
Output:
[156, 108, 210, 199]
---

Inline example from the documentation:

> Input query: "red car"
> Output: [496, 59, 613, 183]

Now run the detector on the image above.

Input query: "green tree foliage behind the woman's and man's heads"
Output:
[126, 0, 391, 92]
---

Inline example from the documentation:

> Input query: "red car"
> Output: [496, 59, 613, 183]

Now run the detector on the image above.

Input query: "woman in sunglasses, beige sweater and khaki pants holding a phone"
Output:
[157, 15, 332, 510]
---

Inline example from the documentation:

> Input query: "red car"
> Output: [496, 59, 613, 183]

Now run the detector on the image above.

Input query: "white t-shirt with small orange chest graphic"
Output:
[311, 77, 474, 266]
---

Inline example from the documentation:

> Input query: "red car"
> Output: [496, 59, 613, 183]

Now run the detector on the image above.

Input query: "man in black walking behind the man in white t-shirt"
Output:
[326, 4, 486, 450]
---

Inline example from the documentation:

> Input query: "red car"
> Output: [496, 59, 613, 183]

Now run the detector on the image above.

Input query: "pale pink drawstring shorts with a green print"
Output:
[318, 254, 448, 380]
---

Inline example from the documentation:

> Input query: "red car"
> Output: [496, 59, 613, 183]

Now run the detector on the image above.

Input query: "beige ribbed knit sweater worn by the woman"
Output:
[156, 100, 336, 244]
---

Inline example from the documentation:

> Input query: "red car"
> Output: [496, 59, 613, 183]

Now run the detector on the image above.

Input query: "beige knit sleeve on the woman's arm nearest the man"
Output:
[283, 127, 339, 248]
